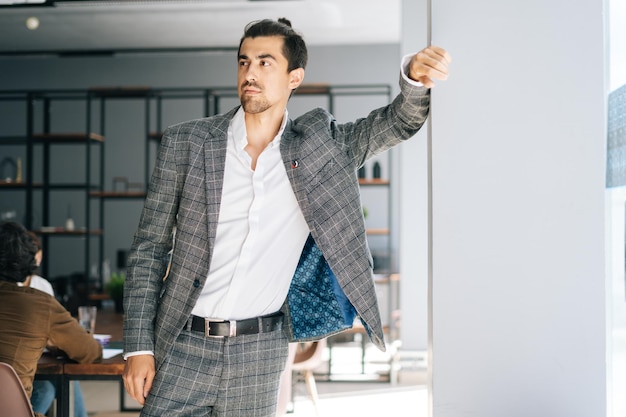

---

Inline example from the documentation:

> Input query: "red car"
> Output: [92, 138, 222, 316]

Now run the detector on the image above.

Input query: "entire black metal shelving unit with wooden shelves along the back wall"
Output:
[0, 84, 393, 328]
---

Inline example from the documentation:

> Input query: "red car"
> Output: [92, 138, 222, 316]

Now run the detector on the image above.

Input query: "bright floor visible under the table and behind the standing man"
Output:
[81, 346, 427, 417]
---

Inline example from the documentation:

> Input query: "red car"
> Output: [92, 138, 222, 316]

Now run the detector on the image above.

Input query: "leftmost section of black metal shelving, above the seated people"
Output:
[0, 90, 104, 302]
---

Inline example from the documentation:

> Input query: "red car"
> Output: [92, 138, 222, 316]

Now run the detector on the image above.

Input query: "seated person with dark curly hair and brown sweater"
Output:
[0, 222, 102, 412]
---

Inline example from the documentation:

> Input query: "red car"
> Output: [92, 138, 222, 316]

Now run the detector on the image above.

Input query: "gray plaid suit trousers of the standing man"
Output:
[141, 329, 289, 417]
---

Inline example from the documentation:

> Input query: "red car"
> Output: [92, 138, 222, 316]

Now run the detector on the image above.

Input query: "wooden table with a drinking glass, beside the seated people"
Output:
[35, 309, 132, 417]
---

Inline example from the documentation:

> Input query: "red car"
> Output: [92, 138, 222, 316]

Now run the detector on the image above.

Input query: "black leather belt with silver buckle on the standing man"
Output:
[185, 312, 283, 337]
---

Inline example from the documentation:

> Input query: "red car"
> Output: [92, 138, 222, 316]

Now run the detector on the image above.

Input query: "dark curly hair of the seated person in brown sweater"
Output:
[0, 222, 37, 282]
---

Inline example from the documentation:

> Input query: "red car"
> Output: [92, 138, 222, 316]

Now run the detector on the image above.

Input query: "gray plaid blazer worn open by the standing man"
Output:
[124, 77, 429, 366]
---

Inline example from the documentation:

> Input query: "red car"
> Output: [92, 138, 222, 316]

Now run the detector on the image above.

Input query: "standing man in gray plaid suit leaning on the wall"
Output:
[124, 19, 450, 417]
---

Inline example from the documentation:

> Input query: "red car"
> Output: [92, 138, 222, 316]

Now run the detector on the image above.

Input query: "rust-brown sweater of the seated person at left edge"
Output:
[0, 281, 102, 396]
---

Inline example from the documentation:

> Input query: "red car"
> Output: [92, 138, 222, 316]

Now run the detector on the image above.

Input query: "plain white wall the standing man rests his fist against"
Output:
[431, 0, 606, 417]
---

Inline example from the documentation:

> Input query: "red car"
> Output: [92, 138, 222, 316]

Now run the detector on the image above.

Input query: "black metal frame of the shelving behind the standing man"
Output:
[0, 83, 394, 318]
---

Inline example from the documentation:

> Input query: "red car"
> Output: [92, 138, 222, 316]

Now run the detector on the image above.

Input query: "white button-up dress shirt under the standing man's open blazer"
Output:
[192, 108, 309, 320]
